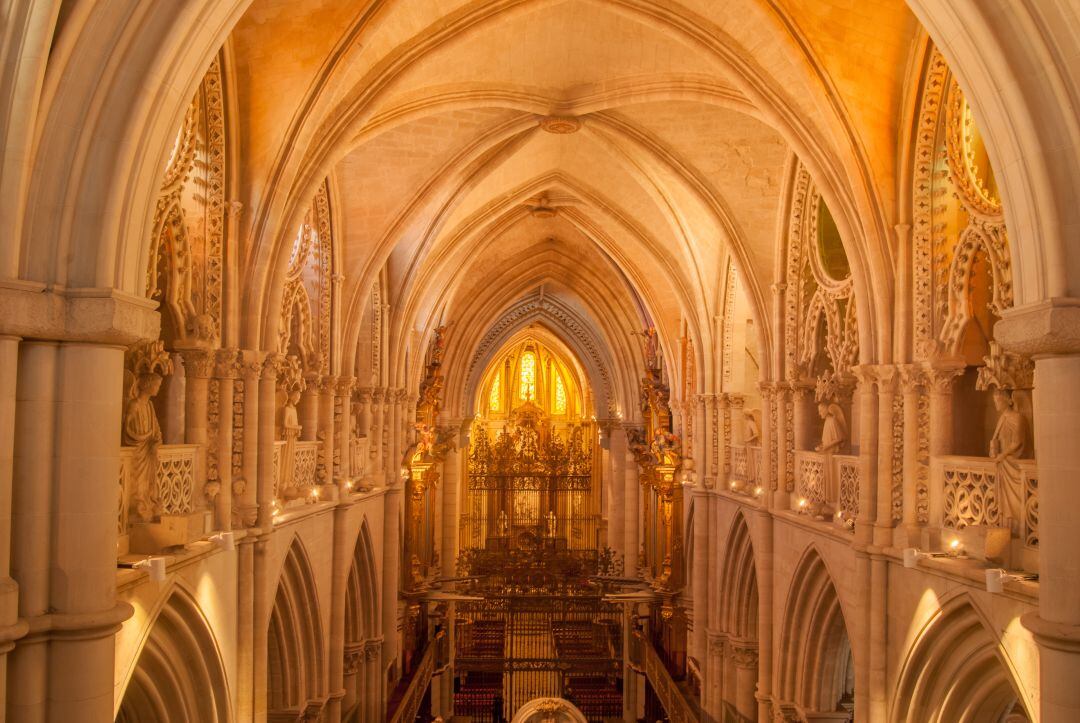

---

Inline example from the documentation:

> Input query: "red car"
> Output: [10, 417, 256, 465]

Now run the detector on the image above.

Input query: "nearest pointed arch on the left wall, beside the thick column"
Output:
[117, 586, 232, 723]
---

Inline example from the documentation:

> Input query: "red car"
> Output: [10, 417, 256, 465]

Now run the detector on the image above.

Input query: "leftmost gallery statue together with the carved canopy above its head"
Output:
[122, 340, 173, 522]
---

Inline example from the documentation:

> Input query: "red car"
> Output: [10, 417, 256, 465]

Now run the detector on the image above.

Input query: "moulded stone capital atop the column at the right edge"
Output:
[994, 297, 1080, 357]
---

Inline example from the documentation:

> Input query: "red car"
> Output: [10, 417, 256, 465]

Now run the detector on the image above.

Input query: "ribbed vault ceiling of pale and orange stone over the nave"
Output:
[223, 0, 918, 402]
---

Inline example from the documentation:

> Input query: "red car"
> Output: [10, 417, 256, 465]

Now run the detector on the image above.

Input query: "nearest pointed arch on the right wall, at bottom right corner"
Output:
[890, 595, 1032, 723]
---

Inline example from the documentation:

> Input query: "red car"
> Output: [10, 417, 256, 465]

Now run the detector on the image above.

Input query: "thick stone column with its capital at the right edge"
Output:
[994, 299, 1080, 723]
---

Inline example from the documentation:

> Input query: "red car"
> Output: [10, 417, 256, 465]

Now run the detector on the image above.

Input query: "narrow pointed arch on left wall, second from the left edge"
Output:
[267, 537, 325, 717]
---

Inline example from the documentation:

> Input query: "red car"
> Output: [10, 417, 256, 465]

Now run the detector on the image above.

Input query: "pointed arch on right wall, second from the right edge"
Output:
[778, 545, 854, 713]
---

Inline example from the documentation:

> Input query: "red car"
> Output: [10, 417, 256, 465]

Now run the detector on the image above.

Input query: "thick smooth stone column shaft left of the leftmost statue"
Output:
[44, 343, 132, 723]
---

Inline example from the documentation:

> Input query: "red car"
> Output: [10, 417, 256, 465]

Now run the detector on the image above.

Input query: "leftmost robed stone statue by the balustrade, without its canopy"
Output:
[123, 372, 161, 522]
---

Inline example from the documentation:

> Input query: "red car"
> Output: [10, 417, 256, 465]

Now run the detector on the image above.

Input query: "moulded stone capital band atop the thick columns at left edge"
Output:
[0, 279, 161, 346]
